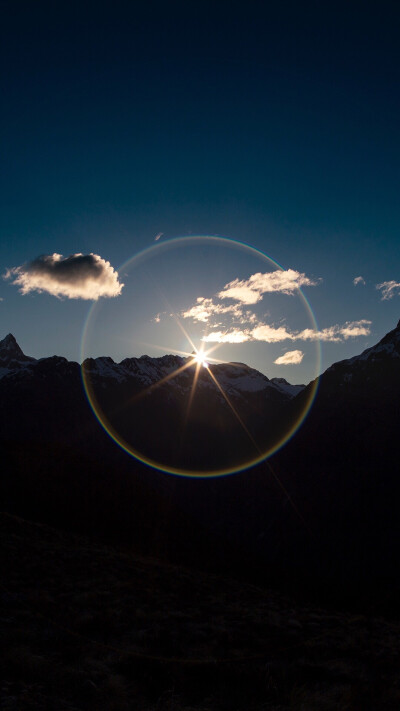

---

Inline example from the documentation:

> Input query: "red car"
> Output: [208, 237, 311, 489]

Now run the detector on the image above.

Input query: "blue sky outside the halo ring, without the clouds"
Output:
[0, 0, 400, 378]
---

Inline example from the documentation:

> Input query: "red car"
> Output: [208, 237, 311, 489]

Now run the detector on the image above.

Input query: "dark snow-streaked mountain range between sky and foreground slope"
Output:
[0, 325, 400, 607]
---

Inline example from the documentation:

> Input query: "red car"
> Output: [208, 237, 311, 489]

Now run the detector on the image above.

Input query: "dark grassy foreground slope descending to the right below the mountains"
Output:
[0, 514, 400, 711]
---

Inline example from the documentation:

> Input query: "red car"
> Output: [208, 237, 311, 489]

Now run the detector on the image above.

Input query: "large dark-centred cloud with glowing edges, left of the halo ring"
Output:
[4, 253, 124, 301]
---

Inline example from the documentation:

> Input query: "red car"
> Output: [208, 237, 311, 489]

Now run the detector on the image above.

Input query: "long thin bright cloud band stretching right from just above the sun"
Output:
[202, 319, 371, 343]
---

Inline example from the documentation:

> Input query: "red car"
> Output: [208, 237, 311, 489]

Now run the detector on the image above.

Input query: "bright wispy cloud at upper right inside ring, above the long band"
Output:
[218, 269, 320, 304]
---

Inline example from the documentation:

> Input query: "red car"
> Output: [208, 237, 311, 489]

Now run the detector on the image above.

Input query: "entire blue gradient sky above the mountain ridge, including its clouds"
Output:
[0, 0, 400, 382]
